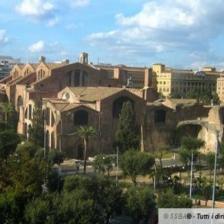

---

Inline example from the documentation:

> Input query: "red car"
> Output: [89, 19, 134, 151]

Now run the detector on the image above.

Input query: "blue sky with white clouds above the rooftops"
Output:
[0, 0, 224, 68]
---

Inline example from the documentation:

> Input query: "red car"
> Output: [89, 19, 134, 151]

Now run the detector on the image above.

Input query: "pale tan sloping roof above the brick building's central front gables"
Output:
[68, 87, 124, 102]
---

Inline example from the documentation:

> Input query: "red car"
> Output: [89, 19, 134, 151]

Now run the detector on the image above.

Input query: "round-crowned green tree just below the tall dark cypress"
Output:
[119, 150, 155, 185]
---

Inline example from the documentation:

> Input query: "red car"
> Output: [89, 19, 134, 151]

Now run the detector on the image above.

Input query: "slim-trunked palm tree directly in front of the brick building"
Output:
[76, 126, 96, 173]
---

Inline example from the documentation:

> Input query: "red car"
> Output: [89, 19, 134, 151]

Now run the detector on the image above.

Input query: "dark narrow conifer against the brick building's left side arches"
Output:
[28, 105, 44, 147]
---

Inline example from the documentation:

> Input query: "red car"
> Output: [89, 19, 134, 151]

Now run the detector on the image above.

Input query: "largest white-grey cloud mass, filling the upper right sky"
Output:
[87, 0, 224, 66]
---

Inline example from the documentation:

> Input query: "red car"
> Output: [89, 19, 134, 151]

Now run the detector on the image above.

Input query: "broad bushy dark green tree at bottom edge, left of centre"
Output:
[62, 176, 123, 223]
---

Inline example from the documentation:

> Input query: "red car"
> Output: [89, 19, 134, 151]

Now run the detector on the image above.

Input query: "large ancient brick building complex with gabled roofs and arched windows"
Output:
[0, 53, 223, 158]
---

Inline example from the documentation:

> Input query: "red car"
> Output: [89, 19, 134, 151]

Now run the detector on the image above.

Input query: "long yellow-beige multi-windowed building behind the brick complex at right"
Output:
[152, 64, 220, 97]
